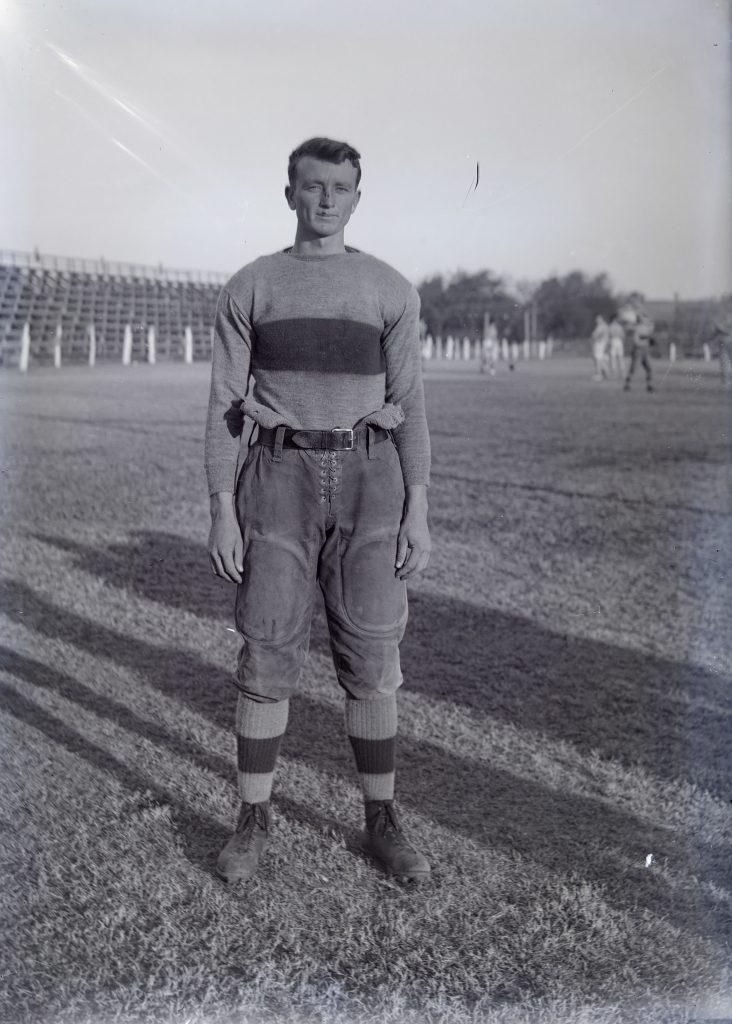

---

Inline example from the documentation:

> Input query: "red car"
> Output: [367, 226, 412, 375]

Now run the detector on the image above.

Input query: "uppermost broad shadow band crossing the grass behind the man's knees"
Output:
[30, 532, 732, 797]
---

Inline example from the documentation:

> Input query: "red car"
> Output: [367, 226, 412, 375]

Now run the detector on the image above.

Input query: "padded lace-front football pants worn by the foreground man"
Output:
[235, 437, 407, 701]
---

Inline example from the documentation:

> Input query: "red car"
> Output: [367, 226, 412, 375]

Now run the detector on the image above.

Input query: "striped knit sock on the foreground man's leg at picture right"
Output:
[346, 694, 396, 801]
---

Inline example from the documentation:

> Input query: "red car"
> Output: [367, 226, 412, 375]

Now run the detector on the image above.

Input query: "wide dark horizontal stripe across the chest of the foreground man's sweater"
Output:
[252, 317, 386, 376]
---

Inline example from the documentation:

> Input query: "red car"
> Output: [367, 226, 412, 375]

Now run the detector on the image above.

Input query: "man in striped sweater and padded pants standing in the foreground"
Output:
[206, 138, 430, 882]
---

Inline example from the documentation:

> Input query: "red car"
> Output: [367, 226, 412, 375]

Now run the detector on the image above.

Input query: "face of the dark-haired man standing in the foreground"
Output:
[285, 157, 360, 239]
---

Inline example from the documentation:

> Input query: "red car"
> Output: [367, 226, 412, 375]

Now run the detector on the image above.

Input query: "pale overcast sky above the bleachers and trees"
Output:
[0, 0, 732, 297]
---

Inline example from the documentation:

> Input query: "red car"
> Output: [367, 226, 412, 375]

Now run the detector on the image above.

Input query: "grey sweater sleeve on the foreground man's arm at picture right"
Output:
[382, 286, 430, 484]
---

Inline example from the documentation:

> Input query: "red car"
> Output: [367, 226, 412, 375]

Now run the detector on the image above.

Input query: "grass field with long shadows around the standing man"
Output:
[0, 359, 732, 1024]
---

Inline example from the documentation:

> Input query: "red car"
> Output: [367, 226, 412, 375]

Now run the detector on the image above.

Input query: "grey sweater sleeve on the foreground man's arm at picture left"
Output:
[204, 288, 253, 495]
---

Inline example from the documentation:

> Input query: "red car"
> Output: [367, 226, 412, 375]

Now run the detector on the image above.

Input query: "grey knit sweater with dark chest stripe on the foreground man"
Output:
[205, 248, 430, 494]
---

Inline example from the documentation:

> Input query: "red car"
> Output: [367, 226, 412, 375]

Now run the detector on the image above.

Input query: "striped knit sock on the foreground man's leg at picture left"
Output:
[236, 693, 290, 804]
